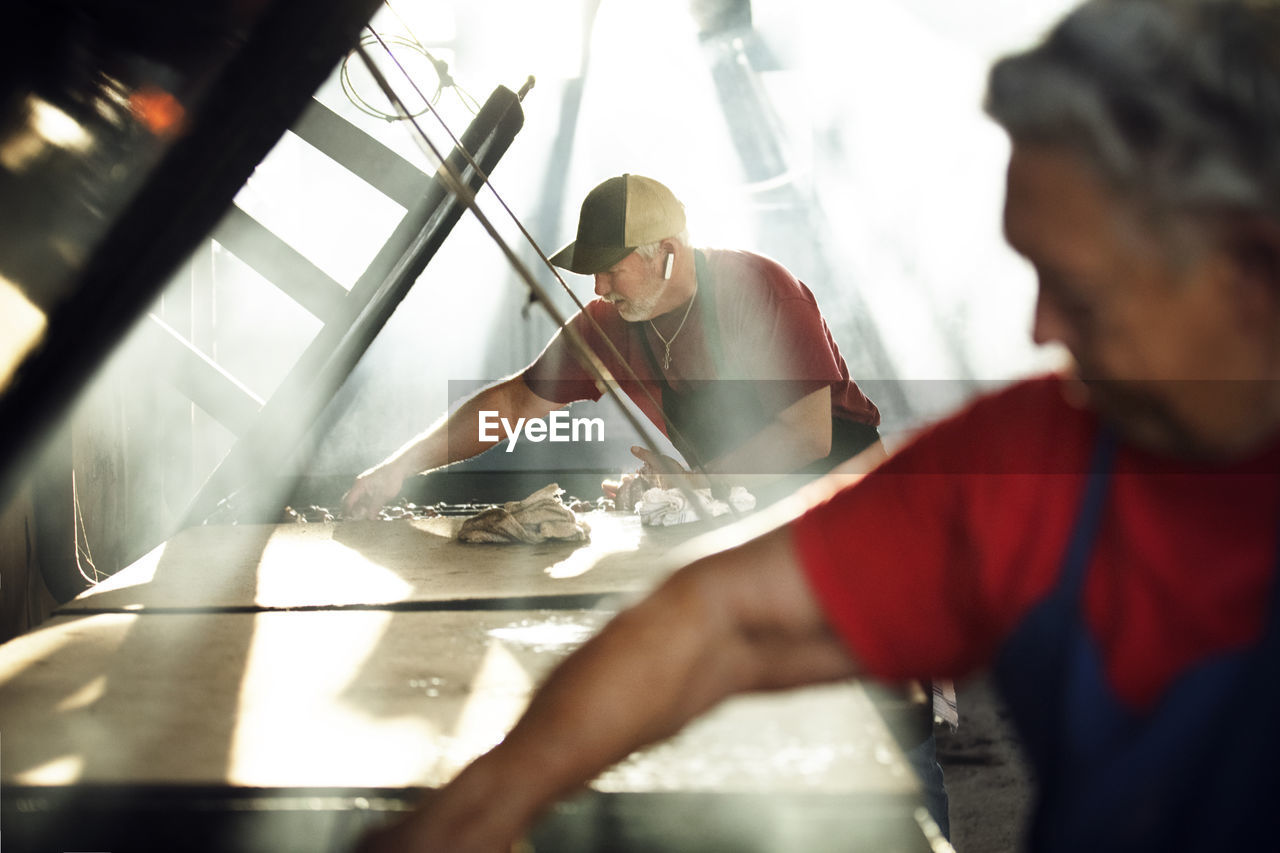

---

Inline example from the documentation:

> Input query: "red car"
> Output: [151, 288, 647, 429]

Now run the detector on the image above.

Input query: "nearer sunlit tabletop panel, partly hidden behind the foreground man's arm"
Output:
[0, 611, 915, 788]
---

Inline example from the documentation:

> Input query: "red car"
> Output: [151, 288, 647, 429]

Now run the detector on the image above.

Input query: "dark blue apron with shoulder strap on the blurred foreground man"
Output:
[996, 422, 1280, 853]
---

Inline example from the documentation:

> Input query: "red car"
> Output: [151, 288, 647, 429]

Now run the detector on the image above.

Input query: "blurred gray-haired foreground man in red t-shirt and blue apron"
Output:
[353, 0, 1280, 853]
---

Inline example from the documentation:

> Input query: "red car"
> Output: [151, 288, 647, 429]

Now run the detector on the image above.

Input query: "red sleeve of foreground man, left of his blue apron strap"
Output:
[794, 382, 1092, 680]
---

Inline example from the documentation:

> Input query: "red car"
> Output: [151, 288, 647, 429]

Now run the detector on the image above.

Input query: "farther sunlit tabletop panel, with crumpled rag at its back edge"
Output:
[61, 512, 723, 612]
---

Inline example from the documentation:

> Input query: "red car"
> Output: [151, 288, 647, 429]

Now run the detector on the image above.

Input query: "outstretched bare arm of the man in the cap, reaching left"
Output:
[342, 374, 563, 519]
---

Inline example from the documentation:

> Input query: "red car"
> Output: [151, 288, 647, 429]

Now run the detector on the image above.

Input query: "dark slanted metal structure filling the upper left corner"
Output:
[0, 0, 378, 505]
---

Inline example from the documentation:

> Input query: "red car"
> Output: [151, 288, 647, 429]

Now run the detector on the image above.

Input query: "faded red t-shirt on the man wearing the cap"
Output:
[524, 250, 879, 433]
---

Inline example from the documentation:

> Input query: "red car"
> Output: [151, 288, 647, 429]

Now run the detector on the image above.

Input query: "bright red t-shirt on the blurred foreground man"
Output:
[795, 378, 1280, 710]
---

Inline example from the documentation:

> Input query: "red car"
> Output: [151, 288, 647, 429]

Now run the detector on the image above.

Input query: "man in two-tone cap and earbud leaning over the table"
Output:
[344, 174, 879, 517]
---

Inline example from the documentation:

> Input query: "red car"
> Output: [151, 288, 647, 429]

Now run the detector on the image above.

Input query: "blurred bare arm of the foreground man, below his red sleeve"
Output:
[362, 517, 855, 853]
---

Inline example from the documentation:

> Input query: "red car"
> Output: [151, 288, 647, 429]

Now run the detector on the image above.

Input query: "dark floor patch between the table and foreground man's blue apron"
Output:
[937, 678, 1033, 853]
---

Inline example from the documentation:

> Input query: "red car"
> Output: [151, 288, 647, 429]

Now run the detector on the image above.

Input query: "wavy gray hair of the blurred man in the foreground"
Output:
[986, 0, 1280, 218]
